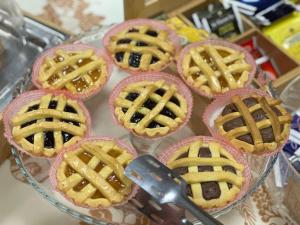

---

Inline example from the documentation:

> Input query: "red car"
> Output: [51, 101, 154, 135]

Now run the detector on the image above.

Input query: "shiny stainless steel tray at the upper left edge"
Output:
[0, 10, 69, 112]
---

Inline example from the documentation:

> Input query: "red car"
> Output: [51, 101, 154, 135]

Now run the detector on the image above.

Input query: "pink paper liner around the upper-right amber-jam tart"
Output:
[177, 39, 256, 98]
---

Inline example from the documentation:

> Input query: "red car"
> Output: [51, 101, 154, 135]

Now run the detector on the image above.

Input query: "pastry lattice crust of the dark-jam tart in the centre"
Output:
[117, 81, 185, 132]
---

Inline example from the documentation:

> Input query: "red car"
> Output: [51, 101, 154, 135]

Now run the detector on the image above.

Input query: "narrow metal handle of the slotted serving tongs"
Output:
[176, 197, 223, 225]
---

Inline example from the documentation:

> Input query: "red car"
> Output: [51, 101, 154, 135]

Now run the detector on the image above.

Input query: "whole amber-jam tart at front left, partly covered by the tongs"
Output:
[51, 139, 134, 208]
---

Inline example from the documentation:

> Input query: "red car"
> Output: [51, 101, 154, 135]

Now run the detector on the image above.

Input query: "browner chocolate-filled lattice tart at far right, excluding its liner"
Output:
[215, 93, 291, 154]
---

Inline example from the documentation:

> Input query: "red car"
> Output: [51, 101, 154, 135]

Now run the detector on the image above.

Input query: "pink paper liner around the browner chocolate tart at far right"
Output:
[202, 88, 289, 157]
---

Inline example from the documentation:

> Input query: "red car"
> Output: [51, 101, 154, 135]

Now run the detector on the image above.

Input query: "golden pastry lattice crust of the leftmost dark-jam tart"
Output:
[12, 94, 86, 156]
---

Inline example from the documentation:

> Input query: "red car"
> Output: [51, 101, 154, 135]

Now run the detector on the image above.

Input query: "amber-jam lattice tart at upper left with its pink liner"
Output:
[33, 44, 110, 98]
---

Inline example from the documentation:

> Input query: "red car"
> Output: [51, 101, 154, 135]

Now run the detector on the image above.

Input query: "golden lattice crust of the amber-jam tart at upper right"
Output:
[184, 45, 251, 92]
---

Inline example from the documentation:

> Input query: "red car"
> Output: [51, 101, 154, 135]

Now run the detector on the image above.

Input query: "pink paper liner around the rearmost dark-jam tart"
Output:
[102, 19, 180, 75]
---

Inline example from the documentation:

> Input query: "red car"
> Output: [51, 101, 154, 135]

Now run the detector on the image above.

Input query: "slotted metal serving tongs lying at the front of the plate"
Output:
[125, 155, 222, 225]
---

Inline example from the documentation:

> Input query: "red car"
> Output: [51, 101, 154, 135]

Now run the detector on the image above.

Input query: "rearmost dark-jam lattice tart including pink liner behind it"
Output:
[106, 19, 176, 72]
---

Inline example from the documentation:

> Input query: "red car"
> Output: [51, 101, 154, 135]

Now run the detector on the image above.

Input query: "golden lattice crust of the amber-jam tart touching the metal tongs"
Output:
[58, 143, 132, 206]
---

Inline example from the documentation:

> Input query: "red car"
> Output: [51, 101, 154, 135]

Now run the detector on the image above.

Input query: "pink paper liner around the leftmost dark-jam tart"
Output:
[3, 90, 91, 158]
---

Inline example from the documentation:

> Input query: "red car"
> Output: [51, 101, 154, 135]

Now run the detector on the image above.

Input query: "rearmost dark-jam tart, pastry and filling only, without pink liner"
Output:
[110, 25, 174, 70]
